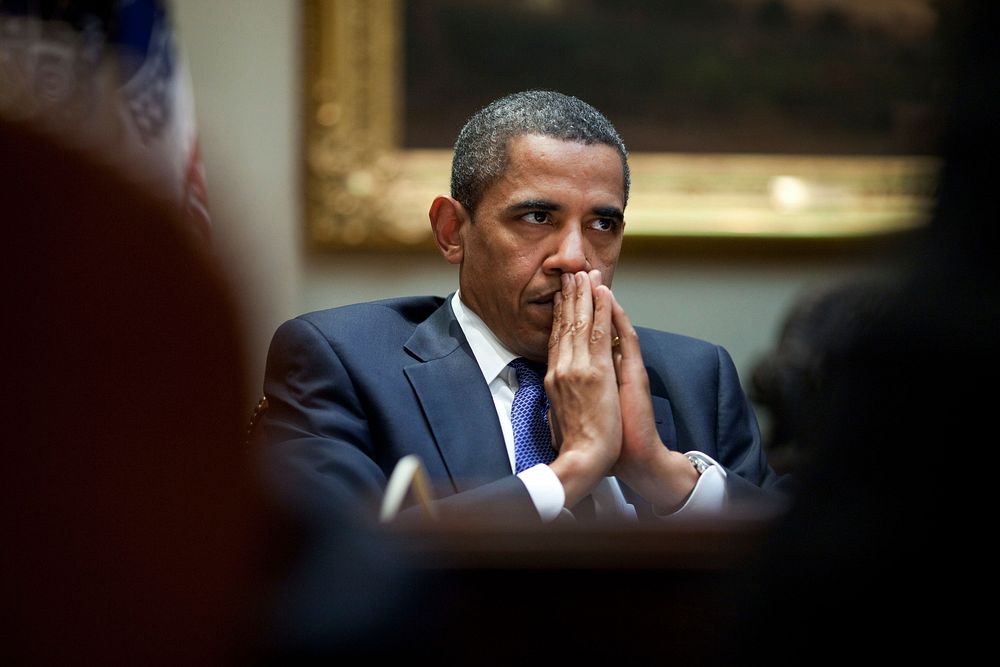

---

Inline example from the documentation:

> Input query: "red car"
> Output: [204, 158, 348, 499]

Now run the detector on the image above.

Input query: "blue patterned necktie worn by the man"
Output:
[510, 358, 556, 473]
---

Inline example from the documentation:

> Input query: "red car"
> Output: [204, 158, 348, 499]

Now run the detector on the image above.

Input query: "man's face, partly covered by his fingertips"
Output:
[459, 134, 625, 362]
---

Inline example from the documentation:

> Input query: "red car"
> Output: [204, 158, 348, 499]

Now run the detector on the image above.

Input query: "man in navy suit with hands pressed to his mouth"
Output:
[262, 91, 780, 521]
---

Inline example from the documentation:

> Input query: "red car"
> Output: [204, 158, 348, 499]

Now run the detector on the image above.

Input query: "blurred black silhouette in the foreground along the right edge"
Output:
[721, 2, 1000, 664]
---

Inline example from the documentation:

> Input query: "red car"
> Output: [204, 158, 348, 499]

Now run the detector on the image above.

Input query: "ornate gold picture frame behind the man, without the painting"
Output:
[303, 0, 938, 250]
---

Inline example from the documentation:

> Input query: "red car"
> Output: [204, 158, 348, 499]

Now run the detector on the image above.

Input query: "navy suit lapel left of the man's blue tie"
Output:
[404, 297, 512, 492]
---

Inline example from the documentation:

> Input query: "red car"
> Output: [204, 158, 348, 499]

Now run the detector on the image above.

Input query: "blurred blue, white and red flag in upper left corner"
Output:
[0, 0, 210, 239]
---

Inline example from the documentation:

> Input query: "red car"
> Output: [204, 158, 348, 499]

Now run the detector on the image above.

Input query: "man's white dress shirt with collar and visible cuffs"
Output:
[451, 292, 726, 521]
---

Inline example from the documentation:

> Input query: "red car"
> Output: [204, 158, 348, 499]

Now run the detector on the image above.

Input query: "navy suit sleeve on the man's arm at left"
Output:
[261, 319, 538, 522]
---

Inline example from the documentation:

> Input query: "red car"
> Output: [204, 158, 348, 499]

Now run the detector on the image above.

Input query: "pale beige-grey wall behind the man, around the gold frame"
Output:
[174, 0, 892, 408]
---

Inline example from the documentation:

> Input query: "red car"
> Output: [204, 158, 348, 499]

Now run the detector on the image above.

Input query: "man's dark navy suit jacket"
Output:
[260, 297, 781, 520]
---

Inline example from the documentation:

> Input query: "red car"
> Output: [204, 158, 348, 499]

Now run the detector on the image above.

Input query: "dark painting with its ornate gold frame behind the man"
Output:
[303, 0, 943, 250]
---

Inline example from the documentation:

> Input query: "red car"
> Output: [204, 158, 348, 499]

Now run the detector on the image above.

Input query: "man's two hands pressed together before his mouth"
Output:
[545, 271, 697, 511]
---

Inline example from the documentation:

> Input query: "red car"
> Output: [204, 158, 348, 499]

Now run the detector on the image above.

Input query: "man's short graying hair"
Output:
[451, 90, 630, 214]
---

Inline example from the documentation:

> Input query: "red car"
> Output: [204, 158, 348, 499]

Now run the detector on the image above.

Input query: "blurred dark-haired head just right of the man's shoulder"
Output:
[747, 275, 893, 472]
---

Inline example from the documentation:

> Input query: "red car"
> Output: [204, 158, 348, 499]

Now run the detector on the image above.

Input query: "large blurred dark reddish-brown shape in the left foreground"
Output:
[0, 121, 264, 665]
